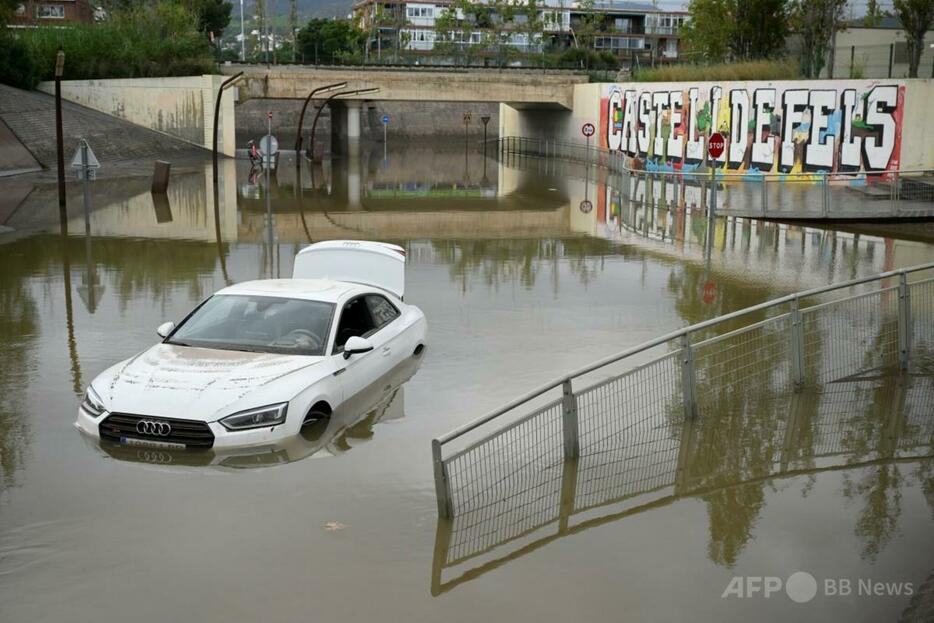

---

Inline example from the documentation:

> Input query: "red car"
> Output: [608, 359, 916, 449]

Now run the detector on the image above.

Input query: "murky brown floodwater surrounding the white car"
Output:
[0, 146, 934, 623]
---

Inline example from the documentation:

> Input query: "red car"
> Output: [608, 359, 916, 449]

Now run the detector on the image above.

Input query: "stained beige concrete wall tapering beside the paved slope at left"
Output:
[39, 75, 236, 156]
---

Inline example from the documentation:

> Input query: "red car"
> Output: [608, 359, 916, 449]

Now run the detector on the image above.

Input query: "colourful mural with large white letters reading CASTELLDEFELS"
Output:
[599, 80, 905, 175]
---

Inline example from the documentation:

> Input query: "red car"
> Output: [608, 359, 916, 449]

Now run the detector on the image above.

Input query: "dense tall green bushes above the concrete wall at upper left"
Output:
[20, 2, 214, 80]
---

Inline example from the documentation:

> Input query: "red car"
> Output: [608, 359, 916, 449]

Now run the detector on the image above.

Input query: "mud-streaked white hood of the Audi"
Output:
[94, 344, 324, 421]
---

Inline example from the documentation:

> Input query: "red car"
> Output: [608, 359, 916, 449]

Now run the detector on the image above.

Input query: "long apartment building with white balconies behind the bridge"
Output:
[353, 0, 688, 64]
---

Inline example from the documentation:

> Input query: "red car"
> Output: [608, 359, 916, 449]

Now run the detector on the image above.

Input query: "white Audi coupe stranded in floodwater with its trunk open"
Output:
[75, 240, 427, 449]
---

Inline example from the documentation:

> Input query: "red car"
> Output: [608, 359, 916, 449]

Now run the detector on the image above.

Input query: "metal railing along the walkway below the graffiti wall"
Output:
[494, 136, 934, 219]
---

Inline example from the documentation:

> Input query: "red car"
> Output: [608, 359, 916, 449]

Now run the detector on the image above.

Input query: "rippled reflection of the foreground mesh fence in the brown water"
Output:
[431, 375, 934, 595]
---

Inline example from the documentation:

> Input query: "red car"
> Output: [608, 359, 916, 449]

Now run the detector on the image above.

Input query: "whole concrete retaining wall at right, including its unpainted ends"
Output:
[500, 79, 934, 173]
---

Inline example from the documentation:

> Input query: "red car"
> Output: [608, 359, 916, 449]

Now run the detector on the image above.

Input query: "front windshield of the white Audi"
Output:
[167, 294, 334, 356]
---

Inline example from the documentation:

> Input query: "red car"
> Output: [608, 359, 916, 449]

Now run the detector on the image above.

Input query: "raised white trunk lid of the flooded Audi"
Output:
[292, 240, 405, 299]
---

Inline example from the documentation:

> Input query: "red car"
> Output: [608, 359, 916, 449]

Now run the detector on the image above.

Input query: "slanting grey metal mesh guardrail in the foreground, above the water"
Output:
[431, 262, 934, 518]
